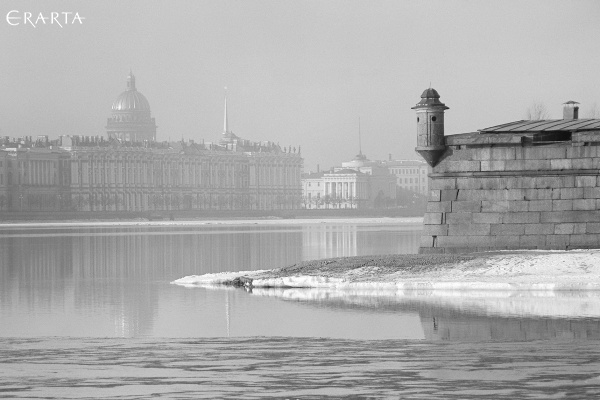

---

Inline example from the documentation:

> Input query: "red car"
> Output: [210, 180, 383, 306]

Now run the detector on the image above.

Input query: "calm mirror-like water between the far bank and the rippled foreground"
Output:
[5, 223, 600, 341]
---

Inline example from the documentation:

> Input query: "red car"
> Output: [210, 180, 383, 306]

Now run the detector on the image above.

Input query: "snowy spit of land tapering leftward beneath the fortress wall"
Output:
[172, 250, 600, 294]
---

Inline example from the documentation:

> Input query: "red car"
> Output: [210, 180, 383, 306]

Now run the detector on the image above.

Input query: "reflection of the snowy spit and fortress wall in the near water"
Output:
[247, 289, 600, 341]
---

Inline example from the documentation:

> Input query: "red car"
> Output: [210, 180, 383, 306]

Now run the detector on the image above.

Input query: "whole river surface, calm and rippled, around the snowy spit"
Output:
[0, 220, 600, 399]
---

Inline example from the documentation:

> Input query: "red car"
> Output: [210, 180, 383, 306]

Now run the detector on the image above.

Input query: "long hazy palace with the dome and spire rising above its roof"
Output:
[0, 73, 303, 211]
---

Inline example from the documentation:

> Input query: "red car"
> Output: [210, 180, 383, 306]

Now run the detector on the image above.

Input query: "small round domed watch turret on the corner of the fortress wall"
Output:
[412, 88, 448, 167]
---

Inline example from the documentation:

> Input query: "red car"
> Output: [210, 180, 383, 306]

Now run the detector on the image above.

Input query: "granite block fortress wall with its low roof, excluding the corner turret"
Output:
[417, 89, 600, 254]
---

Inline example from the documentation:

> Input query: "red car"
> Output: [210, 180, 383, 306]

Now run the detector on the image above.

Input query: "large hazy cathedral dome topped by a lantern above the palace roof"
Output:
[106, 71, 156, 142]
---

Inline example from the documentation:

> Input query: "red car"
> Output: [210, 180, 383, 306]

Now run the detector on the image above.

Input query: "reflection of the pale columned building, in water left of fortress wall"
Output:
[302, 224, 421, 260]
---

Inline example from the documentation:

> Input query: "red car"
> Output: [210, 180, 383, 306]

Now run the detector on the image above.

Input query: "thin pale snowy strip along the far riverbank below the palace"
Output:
[0, 217, 423, 229]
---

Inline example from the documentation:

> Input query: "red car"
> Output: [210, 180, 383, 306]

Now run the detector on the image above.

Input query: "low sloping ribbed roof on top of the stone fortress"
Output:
[479, 119, 600, 133]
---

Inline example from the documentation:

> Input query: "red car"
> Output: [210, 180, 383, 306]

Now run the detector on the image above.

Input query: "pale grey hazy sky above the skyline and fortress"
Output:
[0, 0, 600, 171]
